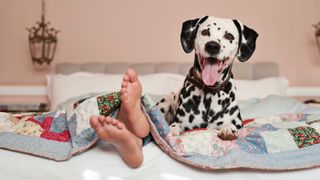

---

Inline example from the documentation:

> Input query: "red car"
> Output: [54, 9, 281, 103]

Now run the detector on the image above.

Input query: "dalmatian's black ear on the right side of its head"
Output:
[233, 20, 258, 62]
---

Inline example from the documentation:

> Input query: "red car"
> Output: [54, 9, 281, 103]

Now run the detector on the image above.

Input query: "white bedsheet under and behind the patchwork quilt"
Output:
[0, 96, 320, 180]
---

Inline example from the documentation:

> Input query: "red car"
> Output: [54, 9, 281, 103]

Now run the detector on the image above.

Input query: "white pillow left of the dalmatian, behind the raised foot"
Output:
[47, 72, 185, 110]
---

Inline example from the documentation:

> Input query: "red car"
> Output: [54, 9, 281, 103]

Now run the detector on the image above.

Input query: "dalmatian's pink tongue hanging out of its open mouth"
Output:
[202, 63, 218, 86]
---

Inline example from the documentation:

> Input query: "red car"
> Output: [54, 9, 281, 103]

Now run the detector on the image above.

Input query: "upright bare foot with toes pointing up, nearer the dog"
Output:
[117, 69, 150, 138]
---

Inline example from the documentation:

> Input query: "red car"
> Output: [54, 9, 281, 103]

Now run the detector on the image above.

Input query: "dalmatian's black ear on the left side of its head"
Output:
[180, 19, 199, 53]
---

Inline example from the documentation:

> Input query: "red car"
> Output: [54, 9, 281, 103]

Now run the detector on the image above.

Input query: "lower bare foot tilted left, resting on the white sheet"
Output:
[90, 116, 143, 168]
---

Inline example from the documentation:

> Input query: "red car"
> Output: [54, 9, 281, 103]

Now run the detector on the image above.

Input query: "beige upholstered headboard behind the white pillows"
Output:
[56, 63, 279, 80]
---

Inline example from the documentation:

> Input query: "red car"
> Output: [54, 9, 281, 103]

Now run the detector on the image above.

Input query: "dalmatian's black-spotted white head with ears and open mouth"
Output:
[180, 16, 258, 86]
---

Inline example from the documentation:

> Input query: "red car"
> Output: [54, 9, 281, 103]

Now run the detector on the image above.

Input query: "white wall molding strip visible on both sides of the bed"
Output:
[0, 86, 320, 97]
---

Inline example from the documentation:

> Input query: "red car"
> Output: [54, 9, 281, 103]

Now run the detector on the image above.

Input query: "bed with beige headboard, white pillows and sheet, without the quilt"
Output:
[0, 63, 320, 180]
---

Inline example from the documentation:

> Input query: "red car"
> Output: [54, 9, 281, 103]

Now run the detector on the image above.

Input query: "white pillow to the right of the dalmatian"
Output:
[235, 77, 289, 100]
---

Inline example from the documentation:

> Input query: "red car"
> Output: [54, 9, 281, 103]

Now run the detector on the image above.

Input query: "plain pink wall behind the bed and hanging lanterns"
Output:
[0, 0, 320, 86]
